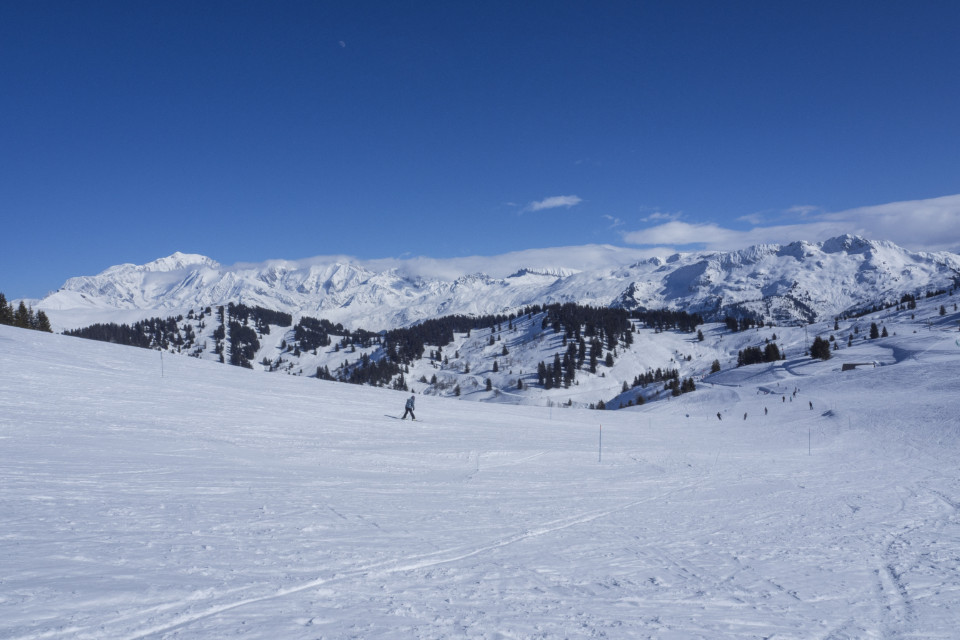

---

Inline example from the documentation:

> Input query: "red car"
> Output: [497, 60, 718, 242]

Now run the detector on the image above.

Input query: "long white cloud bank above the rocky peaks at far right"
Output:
[623, 195, 960, 251]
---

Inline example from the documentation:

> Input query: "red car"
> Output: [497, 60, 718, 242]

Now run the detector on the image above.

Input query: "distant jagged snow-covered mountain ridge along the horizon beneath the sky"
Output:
[35, 235, 960, 330]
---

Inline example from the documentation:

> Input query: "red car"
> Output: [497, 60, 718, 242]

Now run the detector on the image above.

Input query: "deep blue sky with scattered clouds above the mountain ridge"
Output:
[0, 0, 960, 299]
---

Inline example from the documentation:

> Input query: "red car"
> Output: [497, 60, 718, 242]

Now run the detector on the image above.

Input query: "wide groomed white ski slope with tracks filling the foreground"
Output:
[0, 326, 960, 640]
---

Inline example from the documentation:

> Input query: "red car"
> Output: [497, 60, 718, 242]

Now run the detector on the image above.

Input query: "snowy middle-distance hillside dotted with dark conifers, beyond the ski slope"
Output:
[56, 282, 960, 416]
